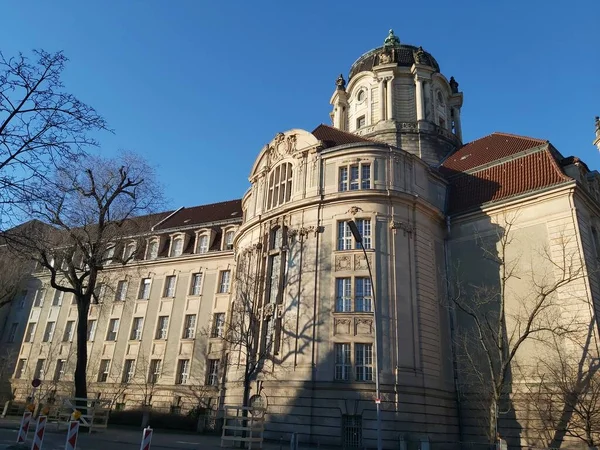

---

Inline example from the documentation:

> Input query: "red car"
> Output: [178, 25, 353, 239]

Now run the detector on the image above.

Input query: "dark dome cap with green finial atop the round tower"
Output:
[348, 30, 440, 80]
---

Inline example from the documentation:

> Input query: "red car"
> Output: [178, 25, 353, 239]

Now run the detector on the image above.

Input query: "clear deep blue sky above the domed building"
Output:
[0, 0, 600, 207]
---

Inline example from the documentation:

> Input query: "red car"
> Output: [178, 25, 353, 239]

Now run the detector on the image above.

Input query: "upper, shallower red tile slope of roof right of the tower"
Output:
[440, 133, 548, 175]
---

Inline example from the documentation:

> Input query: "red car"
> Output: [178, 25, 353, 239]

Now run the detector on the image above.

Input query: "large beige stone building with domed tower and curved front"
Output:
[1, 31, 600, 448]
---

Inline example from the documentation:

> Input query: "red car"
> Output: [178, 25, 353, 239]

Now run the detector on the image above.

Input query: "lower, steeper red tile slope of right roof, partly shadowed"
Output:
[447, 148, 572, 214]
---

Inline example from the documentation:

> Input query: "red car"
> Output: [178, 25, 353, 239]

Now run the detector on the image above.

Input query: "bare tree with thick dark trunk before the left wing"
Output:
[5, 154, 162, 398]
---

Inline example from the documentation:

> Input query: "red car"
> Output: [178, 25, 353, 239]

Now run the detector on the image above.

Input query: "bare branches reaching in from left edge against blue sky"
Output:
[0, 50, 107, 224]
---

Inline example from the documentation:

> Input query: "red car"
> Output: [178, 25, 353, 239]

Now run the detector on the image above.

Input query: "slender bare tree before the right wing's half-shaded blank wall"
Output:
[449, 214, 585, 442]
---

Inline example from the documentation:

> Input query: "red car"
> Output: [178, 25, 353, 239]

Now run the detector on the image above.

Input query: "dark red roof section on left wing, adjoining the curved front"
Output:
[154, 199, 242, 230]
